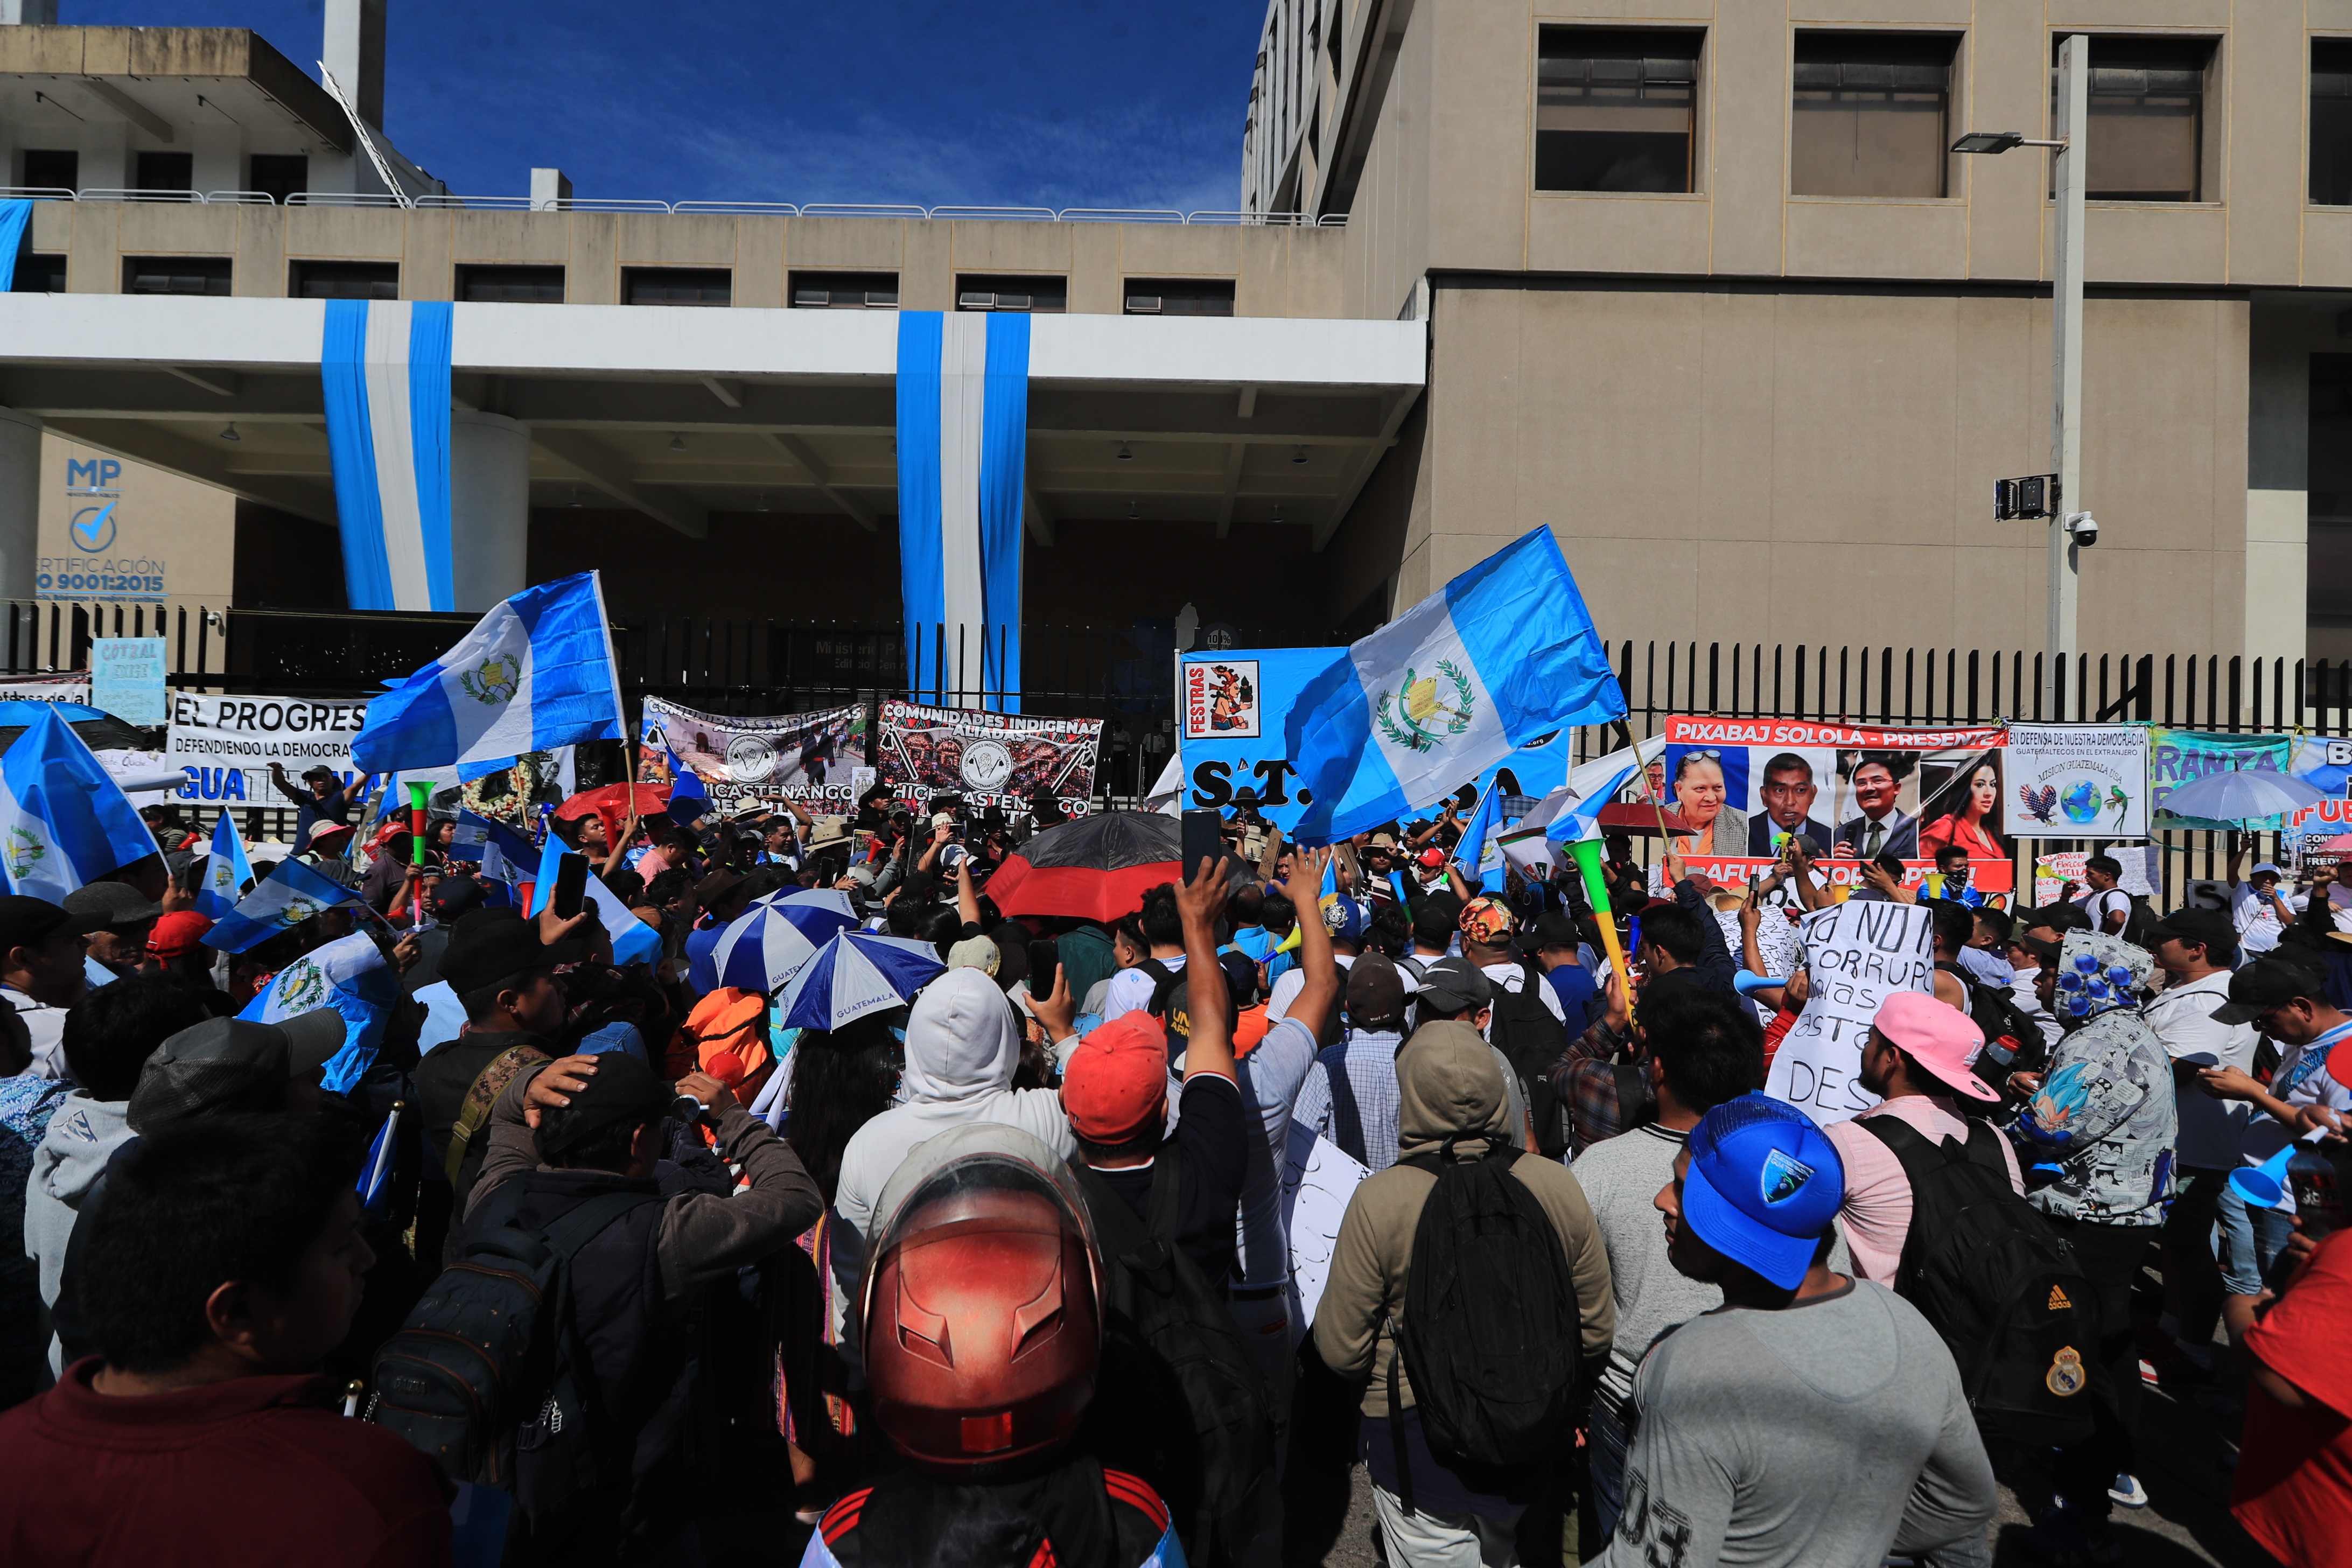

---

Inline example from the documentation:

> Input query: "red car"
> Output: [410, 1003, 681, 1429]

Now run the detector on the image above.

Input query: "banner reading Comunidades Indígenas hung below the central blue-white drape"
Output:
[877, 703, 1103, 816]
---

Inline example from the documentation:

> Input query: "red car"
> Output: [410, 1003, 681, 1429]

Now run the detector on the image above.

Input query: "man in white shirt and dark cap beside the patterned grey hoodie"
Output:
[2140, 910, 2260, 1370]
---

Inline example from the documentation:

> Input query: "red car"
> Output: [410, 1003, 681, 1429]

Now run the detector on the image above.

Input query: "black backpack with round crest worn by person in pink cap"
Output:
[1856, 1117, 2098, 1448]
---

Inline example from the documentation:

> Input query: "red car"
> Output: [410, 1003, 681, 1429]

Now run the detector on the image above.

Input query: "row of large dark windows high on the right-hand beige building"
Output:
[1536, 28, 2352, 207]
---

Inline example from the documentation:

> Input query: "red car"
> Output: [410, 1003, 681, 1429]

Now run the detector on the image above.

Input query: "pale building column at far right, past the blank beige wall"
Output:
[2244, 298, 2312, 661]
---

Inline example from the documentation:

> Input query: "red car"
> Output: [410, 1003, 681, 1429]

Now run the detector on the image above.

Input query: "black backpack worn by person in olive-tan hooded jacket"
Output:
[1388, 1133, 1583, 1509]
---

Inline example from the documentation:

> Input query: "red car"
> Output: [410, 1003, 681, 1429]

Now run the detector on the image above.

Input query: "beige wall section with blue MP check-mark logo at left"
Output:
[36, 432, 232, 606]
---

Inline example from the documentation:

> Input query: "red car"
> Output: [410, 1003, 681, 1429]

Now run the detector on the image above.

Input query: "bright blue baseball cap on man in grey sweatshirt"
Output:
[1682, 1093, 1846, 1291]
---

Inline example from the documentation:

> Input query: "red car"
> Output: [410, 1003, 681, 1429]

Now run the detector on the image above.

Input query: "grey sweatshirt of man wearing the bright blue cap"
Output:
[1599, 1279, 1999, 1568]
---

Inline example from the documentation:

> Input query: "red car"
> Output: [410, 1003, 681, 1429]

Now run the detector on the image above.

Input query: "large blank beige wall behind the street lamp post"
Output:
[1364, 284, 2249, 654]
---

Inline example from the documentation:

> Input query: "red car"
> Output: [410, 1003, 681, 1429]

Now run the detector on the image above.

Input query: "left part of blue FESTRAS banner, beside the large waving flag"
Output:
[1178, 649, 1348, 832]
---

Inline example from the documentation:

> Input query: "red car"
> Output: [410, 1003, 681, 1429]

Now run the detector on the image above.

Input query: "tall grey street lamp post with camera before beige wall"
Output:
[1952, 33, 2098, 719]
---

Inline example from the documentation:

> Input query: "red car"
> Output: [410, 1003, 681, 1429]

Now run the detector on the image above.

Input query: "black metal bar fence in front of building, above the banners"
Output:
[18, 599, 2352, 900]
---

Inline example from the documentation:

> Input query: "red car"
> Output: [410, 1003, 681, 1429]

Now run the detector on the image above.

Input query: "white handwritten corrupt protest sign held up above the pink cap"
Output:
[1764, 898, 1936, 1124]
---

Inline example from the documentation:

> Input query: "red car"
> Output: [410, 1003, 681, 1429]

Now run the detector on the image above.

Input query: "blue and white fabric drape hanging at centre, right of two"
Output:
[899, 310, 1030, 712]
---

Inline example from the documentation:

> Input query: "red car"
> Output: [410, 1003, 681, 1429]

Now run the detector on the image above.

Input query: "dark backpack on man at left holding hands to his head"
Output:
[369, 1192, 661, 1493]
